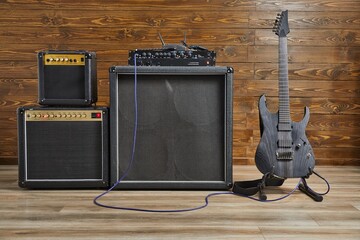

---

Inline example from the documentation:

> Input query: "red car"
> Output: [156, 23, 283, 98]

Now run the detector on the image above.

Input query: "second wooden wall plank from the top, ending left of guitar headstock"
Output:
[0, 9, 249, 31]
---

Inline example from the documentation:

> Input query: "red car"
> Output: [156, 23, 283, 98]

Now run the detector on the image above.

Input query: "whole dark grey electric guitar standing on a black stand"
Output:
[255, 10, 315, 178]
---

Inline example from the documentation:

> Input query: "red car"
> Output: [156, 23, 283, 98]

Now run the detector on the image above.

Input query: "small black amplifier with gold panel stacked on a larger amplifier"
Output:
[38, 50, 97, 106]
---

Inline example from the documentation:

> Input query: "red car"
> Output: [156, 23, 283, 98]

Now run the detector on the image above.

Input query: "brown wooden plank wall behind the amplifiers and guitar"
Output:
[0, 0, 360, 165]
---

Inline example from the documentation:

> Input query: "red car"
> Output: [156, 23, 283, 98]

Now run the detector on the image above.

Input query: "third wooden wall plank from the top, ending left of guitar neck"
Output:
[0, 26, 254, 46]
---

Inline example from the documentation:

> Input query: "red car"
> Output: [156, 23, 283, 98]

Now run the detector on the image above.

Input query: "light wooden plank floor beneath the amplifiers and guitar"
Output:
[0, 166, 360, 240]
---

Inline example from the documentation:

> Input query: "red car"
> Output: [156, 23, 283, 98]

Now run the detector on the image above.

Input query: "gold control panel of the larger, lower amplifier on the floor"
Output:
[25, 109, 104, 121]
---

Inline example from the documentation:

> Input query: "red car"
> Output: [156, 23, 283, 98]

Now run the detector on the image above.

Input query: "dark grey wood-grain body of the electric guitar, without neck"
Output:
[255, 95, 315, 178]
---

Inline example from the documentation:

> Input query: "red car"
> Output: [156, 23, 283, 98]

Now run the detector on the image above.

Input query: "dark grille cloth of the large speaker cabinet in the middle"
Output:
[118, 75, 225, 181]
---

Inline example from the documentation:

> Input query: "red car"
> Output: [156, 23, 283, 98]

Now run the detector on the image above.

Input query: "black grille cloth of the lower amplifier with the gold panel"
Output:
[26, 121, 102, 179]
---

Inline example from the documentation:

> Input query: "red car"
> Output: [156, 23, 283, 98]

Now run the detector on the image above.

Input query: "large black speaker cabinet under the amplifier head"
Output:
[110, 66, 233, 189]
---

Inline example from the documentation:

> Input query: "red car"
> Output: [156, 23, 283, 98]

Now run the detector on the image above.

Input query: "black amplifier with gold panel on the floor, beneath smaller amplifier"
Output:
[17, 107, 109, 189]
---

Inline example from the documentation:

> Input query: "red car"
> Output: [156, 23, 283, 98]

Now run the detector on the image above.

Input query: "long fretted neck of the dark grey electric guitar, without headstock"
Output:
[279, 37, 291, 130]
